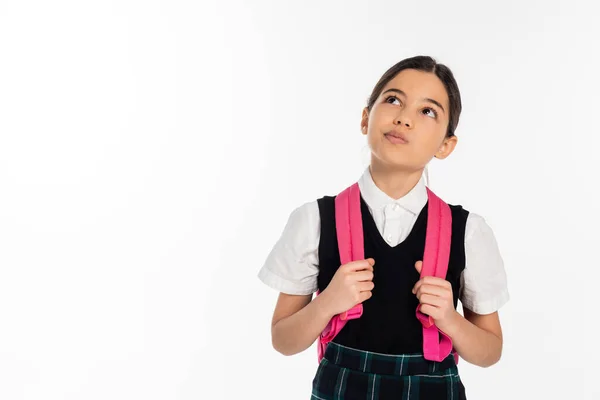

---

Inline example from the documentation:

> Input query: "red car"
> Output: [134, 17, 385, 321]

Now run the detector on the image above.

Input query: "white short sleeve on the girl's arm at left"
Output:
[258, 201, 320, 295]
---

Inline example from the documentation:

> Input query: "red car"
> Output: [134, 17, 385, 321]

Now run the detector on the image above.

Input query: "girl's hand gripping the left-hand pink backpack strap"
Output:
[321, 258, 375, 315]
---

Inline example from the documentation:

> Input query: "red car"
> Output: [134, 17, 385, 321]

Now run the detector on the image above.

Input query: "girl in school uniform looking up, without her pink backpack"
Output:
[259, 56, 509, 400]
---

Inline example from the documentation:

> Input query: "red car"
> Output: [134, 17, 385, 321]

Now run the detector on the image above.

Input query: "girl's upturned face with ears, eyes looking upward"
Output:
[361, 69, 457, 170]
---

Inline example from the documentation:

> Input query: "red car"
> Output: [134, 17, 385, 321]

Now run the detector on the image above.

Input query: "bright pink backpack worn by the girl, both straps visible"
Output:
[317, 183, 458, 363]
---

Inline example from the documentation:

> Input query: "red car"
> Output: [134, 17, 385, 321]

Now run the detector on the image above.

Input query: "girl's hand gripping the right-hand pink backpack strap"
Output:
[412, 261, 460, 333]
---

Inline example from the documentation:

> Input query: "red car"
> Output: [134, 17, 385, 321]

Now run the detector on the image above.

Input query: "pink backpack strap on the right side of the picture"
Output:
[417, 188, 458, 363]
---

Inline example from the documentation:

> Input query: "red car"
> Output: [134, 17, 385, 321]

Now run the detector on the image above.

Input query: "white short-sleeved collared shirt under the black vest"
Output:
[258, 168, 509, 314]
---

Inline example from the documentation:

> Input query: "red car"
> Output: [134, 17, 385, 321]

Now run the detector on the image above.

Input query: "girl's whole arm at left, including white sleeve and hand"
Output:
[259, 201, 374, 356]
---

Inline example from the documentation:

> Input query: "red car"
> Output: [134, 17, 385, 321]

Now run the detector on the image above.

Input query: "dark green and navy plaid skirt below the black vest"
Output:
[311, 342, 466, 400]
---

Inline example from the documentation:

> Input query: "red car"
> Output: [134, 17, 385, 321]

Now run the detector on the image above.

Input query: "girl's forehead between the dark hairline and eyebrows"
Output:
[382, 69, 449, 109]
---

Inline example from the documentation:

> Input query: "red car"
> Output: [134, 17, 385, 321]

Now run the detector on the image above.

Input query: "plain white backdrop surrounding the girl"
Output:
[0, 0, 600, 400]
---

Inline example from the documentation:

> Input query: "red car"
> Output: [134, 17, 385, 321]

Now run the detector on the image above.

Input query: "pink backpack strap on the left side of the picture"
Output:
[317, 183, 364, 362]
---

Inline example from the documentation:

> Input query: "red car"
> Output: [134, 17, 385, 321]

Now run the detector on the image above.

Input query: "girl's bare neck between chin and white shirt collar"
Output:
[369, 160, 423, 200]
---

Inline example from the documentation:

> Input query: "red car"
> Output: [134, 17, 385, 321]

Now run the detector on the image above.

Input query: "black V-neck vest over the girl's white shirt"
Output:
[318, 196, 469, 354]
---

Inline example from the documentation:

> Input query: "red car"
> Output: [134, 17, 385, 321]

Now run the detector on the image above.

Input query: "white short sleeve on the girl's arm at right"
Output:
[460, 213, 509, 314]
